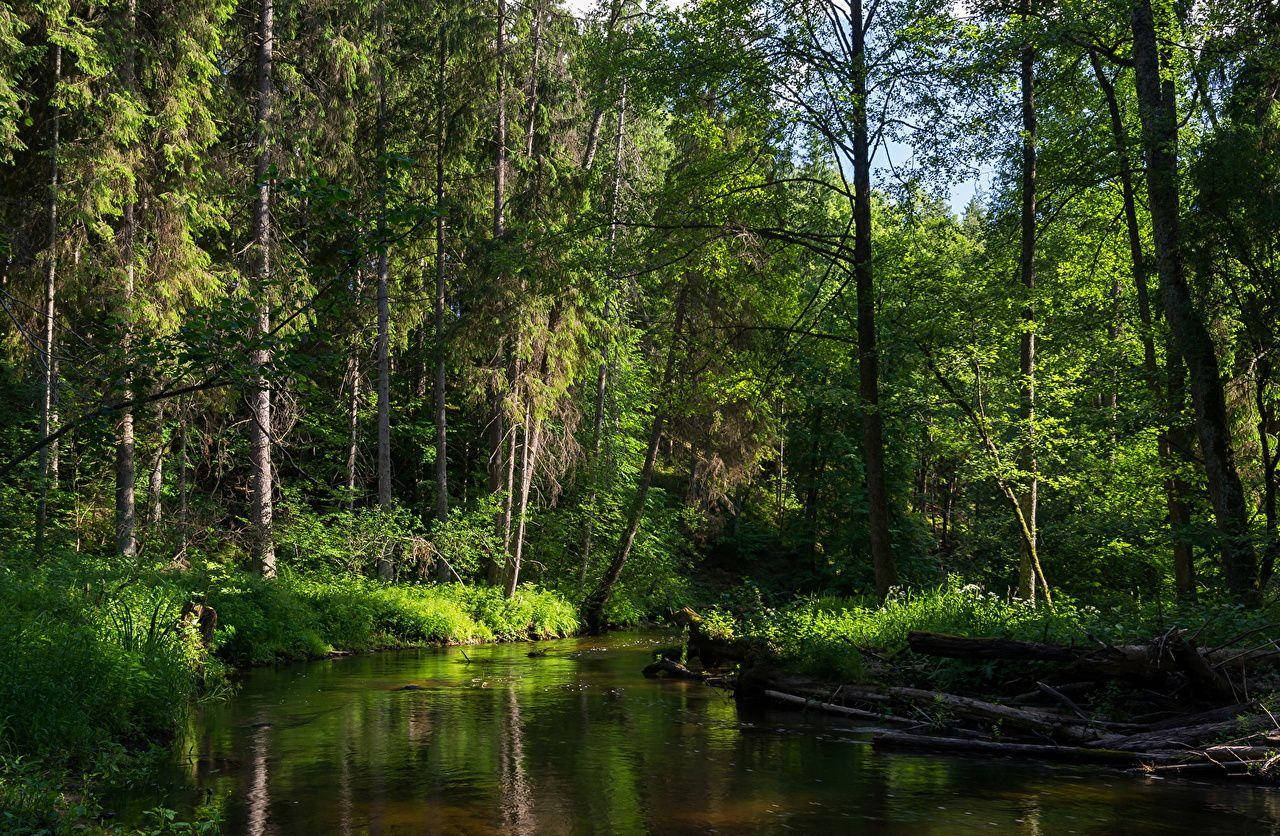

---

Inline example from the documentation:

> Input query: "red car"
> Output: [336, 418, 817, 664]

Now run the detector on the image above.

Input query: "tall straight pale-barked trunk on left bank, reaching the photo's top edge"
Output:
[250, 0, 275, 577]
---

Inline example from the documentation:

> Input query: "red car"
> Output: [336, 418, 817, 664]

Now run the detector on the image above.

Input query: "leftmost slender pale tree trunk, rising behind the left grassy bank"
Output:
[36, 44, 63, 554]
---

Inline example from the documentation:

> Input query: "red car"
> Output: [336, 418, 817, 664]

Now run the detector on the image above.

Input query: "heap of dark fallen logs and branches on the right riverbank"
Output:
[646, 618, 1280, 777]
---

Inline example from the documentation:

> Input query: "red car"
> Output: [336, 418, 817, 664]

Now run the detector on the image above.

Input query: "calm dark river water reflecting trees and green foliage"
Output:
[119, 634, 1280, 836]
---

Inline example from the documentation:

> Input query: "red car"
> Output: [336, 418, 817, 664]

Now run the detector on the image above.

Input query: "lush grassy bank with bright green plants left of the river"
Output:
[0, 558, 579, 833]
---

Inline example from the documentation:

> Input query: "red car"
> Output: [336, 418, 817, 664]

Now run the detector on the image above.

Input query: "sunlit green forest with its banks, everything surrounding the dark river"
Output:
[0, 0, 1280, 833]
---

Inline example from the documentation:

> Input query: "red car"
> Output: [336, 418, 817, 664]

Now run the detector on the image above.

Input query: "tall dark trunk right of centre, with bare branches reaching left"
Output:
[849, 0, 897, 600]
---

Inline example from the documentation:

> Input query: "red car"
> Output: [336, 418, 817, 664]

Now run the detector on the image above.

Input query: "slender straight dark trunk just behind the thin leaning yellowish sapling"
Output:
[1018, 0, 1039, 603]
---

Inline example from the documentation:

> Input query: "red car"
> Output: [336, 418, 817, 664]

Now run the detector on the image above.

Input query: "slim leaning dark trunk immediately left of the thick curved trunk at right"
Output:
[1089, 50, 1196, 598]
